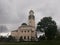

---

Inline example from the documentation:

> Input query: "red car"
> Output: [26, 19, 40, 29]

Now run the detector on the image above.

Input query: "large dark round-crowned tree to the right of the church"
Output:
[37, 17, 57, 39]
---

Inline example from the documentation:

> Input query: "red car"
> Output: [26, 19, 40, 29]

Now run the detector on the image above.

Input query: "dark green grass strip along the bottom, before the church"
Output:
[0, 40, 60, 45]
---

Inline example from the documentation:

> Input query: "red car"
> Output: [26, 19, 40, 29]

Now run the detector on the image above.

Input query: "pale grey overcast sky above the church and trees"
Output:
[0, 0, 60, 32]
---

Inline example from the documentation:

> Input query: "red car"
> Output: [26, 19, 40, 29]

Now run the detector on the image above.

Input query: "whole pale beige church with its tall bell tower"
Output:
[11, 10, 37, 41]
